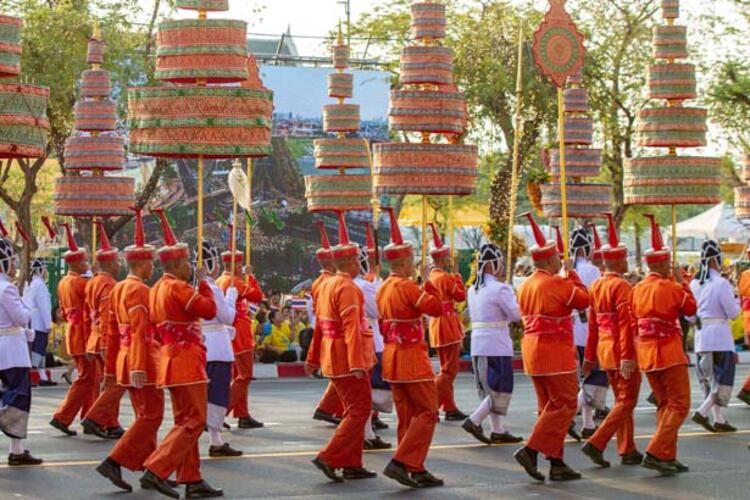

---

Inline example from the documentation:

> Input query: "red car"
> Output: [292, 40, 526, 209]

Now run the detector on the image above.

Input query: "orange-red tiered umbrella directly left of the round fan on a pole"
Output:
[373, 1, 477, 266]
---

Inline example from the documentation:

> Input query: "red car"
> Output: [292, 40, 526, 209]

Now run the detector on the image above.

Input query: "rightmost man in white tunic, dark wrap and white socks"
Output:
[690, 240, 741, 432]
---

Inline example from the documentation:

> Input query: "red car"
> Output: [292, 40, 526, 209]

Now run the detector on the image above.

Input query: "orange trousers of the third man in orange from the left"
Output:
[109, 385, 164, 471]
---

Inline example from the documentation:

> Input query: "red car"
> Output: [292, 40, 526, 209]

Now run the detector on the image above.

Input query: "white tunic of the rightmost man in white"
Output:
[690, 269, 741, 353]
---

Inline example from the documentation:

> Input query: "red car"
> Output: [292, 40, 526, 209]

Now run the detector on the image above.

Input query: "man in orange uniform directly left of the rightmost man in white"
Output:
[632, 214, 698, 474]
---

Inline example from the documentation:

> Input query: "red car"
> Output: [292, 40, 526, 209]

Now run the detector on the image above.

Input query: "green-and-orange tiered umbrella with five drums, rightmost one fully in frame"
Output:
[623, 0, 721, 253]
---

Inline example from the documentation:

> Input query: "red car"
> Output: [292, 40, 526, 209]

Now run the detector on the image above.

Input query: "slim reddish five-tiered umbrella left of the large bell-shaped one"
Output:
[53, 26, 135, 258]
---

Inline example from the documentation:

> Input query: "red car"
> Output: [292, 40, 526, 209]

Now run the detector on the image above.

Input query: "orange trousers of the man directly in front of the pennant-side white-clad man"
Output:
[143, 382, 208, 484]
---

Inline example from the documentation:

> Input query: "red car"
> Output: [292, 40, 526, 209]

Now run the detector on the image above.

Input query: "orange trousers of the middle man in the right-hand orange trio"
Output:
[589, 370, 641, 455]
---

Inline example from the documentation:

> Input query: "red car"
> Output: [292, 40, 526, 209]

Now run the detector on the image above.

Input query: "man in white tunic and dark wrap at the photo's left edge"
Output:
[0, 222, 42, 466]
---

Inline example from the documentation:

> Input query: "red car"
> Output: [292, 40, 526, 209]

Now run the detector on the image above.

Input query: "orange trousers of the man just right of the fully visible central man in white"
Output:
[526, 373, 578, 459]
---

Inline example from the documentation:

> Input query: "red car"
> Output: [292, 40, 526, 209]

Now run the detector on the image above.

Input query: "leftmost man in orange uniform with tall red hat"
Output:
[49, 224, 93, 436]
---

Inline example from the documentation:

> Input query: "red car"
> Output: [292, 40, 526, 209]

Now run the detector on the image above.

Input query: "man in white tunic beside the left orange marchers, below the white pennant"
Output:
[196, 241, 242, 457]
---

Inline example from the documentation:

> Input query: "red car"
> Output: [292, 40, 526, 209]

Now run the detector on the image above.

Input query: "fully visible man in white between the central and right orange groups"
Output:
[462, 243, 523, 444]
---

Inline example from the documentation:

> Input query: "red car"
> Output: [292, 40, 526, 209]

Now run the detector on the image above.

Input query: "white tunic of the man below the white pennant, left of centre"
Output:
[201, 276, 237, 363]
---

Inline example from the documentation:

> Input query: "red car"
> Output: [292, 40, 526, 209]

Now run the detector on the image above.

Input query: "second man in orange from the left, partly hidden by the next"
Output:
[81, 222, 125, 439]
